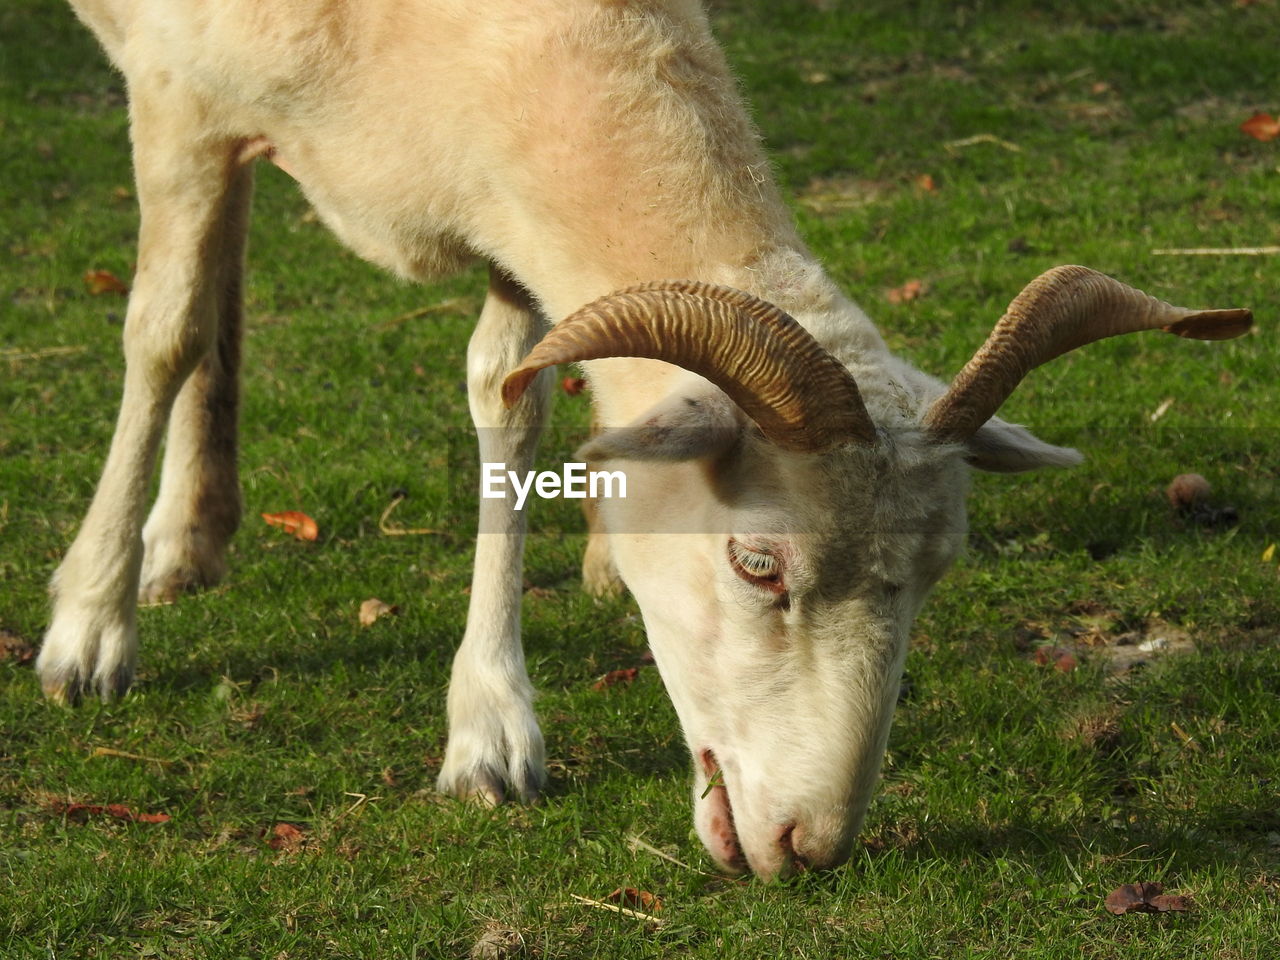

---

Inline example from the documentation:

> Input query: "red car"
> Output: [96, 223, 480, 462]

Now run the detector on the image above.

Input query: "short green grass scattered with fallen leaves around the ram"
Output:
[0, 0, 1280, 960]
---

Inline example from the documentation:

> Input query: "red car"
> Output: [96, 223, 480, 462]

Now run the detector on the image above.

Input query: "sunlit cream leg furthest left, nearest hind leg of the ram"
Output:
[36, 74, 246, 701]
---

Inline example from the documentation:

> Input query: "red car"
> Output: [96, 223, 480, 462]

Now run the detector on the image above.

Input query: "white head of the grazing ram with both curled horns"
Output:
[503, 266, 1251, 876]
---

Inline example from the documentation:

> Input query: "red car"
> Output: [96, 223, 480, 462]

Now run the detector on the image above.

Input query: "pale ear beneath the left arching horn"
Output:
[575, 390, 746, 462]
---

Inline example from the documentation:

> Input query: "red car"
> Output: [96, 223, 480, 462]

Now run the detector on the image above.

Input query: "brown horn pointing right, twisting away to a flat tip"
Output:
[924, 266, 1253, 442]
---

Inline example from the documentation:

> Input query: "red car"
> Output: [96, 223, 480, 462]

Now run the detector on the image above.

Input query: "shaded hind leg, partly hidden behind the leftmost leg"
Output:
[138, 164, 253, 603]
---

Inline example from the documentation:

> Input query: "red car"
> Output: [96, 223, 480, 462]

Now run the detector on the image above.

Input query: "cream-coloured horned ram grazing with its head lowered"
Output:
[38, 0, 1249, 876]
